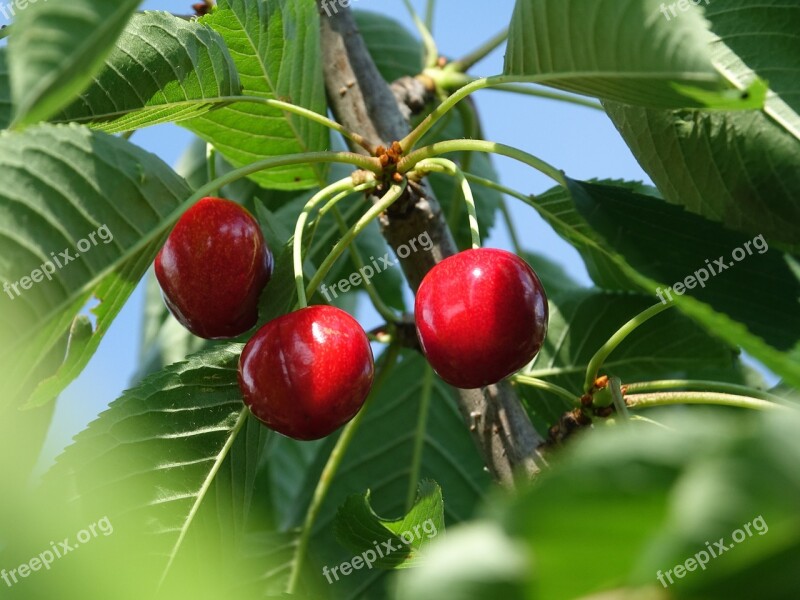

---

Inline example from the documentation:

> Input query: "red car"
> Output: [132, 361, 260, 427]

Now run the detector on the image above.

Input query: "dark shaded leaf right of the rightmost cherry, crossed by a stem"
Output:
[516, 290, 737, 431]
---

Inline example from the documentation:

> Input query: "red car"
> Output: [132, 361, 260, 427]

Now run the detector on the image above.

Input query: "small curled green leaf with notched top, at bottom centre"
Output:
[334, 481, 444, 569]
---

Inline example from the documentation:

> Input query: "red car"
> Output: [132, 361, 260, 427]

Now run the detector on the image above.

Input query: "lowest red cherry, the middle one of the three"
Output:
[239, 306, 375, 440]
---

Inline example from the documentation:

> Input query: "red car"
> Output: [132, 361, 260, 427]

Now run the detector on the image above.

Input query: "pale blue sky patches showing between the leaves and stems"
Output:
[36, 0, 655, 468]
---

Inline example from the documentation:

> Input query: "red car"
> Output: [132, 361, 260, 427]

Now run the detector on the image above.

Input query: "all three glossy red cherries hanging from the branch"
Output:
[155, 198, 548, 440]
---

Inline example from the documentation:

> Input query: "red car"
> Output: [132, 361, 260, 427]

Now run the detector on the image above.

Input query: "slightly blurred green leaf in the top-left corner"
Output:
[8, 0, 140, 126]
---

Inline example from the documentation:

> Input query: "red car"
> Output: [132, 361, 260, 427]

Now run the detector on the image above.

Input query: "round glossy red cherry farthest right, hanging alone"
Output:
[415, 248, 548, 389]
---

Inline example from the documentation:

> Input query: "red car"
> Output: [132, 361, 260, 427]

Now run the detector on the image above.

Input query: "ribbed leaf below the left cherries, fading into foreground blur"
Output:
[48, 344, 269, 593]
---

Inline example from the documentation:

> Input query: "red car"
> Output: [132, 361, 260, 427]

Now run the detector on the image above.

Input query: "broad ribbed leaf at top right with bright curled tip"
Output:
[505, 0, 765, 109]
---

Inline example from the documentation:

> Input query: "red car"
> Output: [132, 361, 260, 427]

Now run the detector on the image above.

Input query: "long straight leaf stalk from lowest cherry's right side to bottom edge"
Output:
[286, 344, 399, 594]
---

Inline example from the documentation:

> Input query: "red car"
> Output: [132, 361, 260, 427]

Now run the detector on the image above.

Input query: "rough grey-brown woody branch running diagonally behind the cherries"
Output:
[320, 2, 544, 486]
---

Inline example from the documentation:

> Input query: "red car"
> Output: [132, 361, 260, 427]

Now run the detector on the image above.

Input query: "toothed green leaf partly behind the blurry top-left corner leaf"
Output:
[54, 12, 241, 133]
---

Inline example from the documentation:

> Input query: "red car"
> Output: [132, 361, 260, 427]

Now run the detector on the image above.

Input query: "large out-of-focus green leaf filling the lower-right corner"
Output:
[503, 409, 800, 600]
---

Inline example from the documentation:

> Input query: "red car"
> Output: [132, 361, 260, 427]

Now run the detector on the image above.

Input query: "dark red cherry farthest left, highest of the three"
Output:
[155, 198, 272, 339]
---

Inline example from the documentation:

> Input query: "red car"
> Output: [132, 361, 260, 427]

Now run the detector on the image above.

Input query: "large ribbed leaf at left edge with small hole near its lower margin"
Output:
[0, 125, 189, 409]
